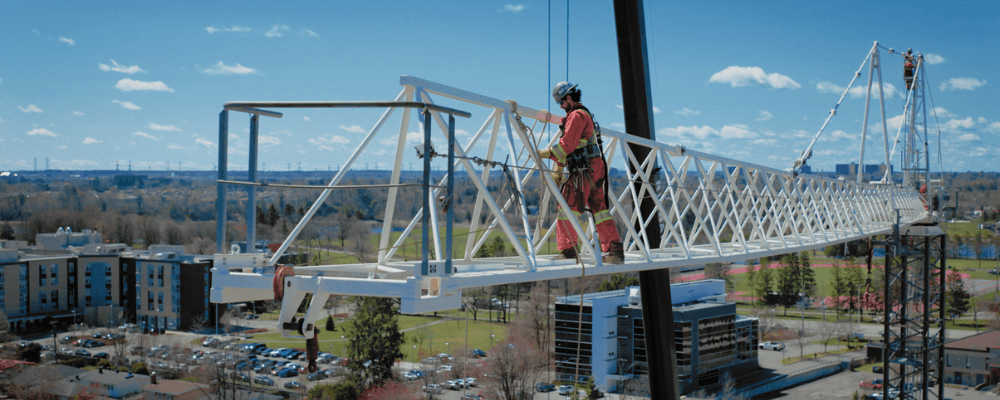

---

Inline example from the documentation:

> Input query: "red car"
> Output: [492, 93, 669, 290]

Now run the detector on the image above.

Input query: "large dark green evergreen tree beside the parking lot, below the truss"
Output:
[347, 296, 405, 386]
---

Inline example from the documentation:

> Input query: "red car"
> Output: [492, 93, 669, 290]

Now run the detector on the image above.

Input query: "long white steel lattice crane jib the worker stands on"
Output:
[212, 76, 929, 338]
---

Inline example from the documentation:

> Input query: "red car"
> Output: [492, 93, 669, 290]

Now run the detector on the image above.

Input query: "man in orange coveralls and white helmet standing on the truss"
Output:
[538, 82, 625, 264]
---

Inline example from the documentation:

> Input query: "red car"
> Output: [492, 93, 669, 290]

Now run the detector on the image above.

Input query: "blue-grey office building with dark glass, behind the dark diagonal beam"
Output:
[555, 279, 759, 394]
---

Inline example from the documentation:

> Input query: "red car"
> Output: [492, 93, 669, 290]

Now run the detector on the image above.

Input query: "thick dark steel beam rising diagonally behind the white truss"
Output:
[614, 0, 680, 400]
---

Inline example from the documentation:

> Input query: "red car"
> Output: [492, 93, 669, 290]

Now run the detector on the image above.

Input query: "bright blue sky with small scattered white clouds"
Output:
[0, 0, 1000, 171]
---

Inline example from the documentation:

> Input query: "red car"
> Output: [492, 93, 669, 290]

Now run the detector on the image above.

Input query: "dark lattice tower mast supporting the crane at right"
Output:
[882, 216, 947, 400]
